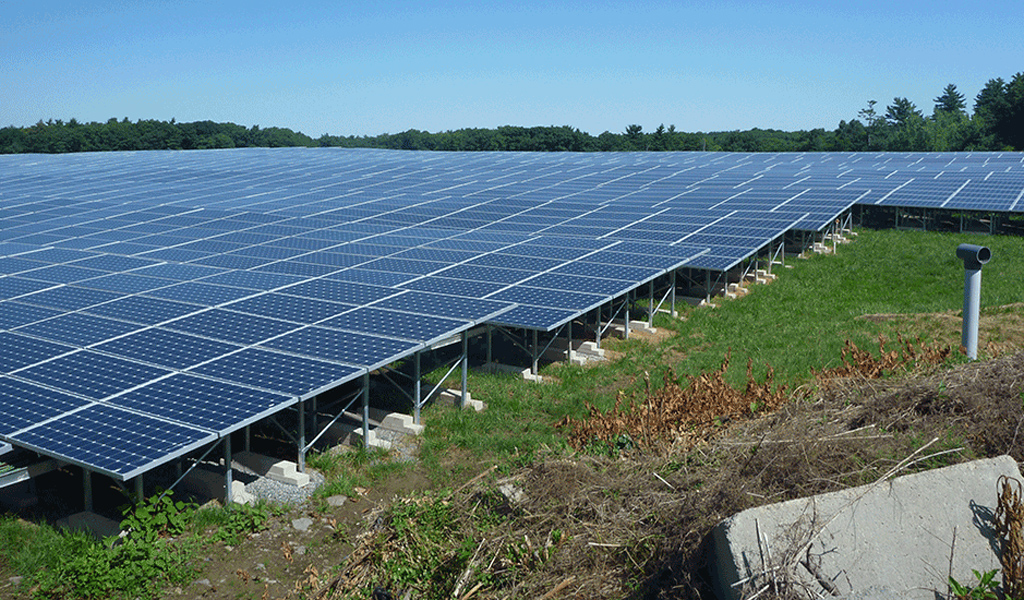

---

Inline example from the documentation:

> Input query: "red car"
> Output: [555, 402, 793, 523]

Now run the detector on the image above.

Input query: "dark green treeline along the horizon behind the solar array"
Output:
[0, 72, 1024, 154]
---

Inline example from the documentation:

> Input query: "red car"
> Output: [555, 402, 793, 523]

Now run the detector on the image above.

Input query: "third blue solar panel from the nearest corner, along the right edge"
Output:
[191, 348, 364, 396]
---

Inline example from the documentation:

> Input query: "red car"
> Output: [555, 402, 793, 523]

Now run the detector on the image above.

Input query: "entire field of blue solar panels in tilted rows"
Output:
[0, 148, 1024, 479]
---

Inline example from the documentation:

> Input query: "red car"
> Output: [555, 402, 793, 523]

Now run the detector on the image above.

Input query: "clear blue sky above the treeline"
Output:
[0, 0, 1024, 137]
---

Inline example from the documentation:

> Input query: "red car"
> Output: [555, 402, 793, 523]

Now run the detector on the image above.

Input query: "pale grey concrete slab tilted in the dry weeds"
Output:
[712, 457, 1021, 600]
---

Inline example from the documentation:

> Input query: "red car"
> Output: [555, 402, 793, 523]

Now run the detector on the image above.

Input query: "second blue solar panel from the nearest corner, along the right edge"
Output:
[111, 374, 295, 434]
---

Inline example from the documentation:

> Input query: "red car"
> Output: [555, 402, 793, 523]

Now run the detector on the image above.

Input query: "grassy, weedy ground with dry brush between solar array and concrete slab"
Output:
[0, 226, 1024, 600]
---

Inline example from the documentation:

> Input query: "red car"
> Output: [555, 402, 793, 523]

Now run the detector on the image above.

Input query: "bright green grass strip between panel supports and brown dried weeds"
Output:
[423, 230, 1024, 466]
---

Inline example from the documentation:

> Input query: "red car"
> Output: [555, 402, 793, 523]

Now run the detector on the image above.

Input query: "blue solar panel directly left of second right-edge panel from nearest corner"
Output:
[18, 350, 168, 399]
